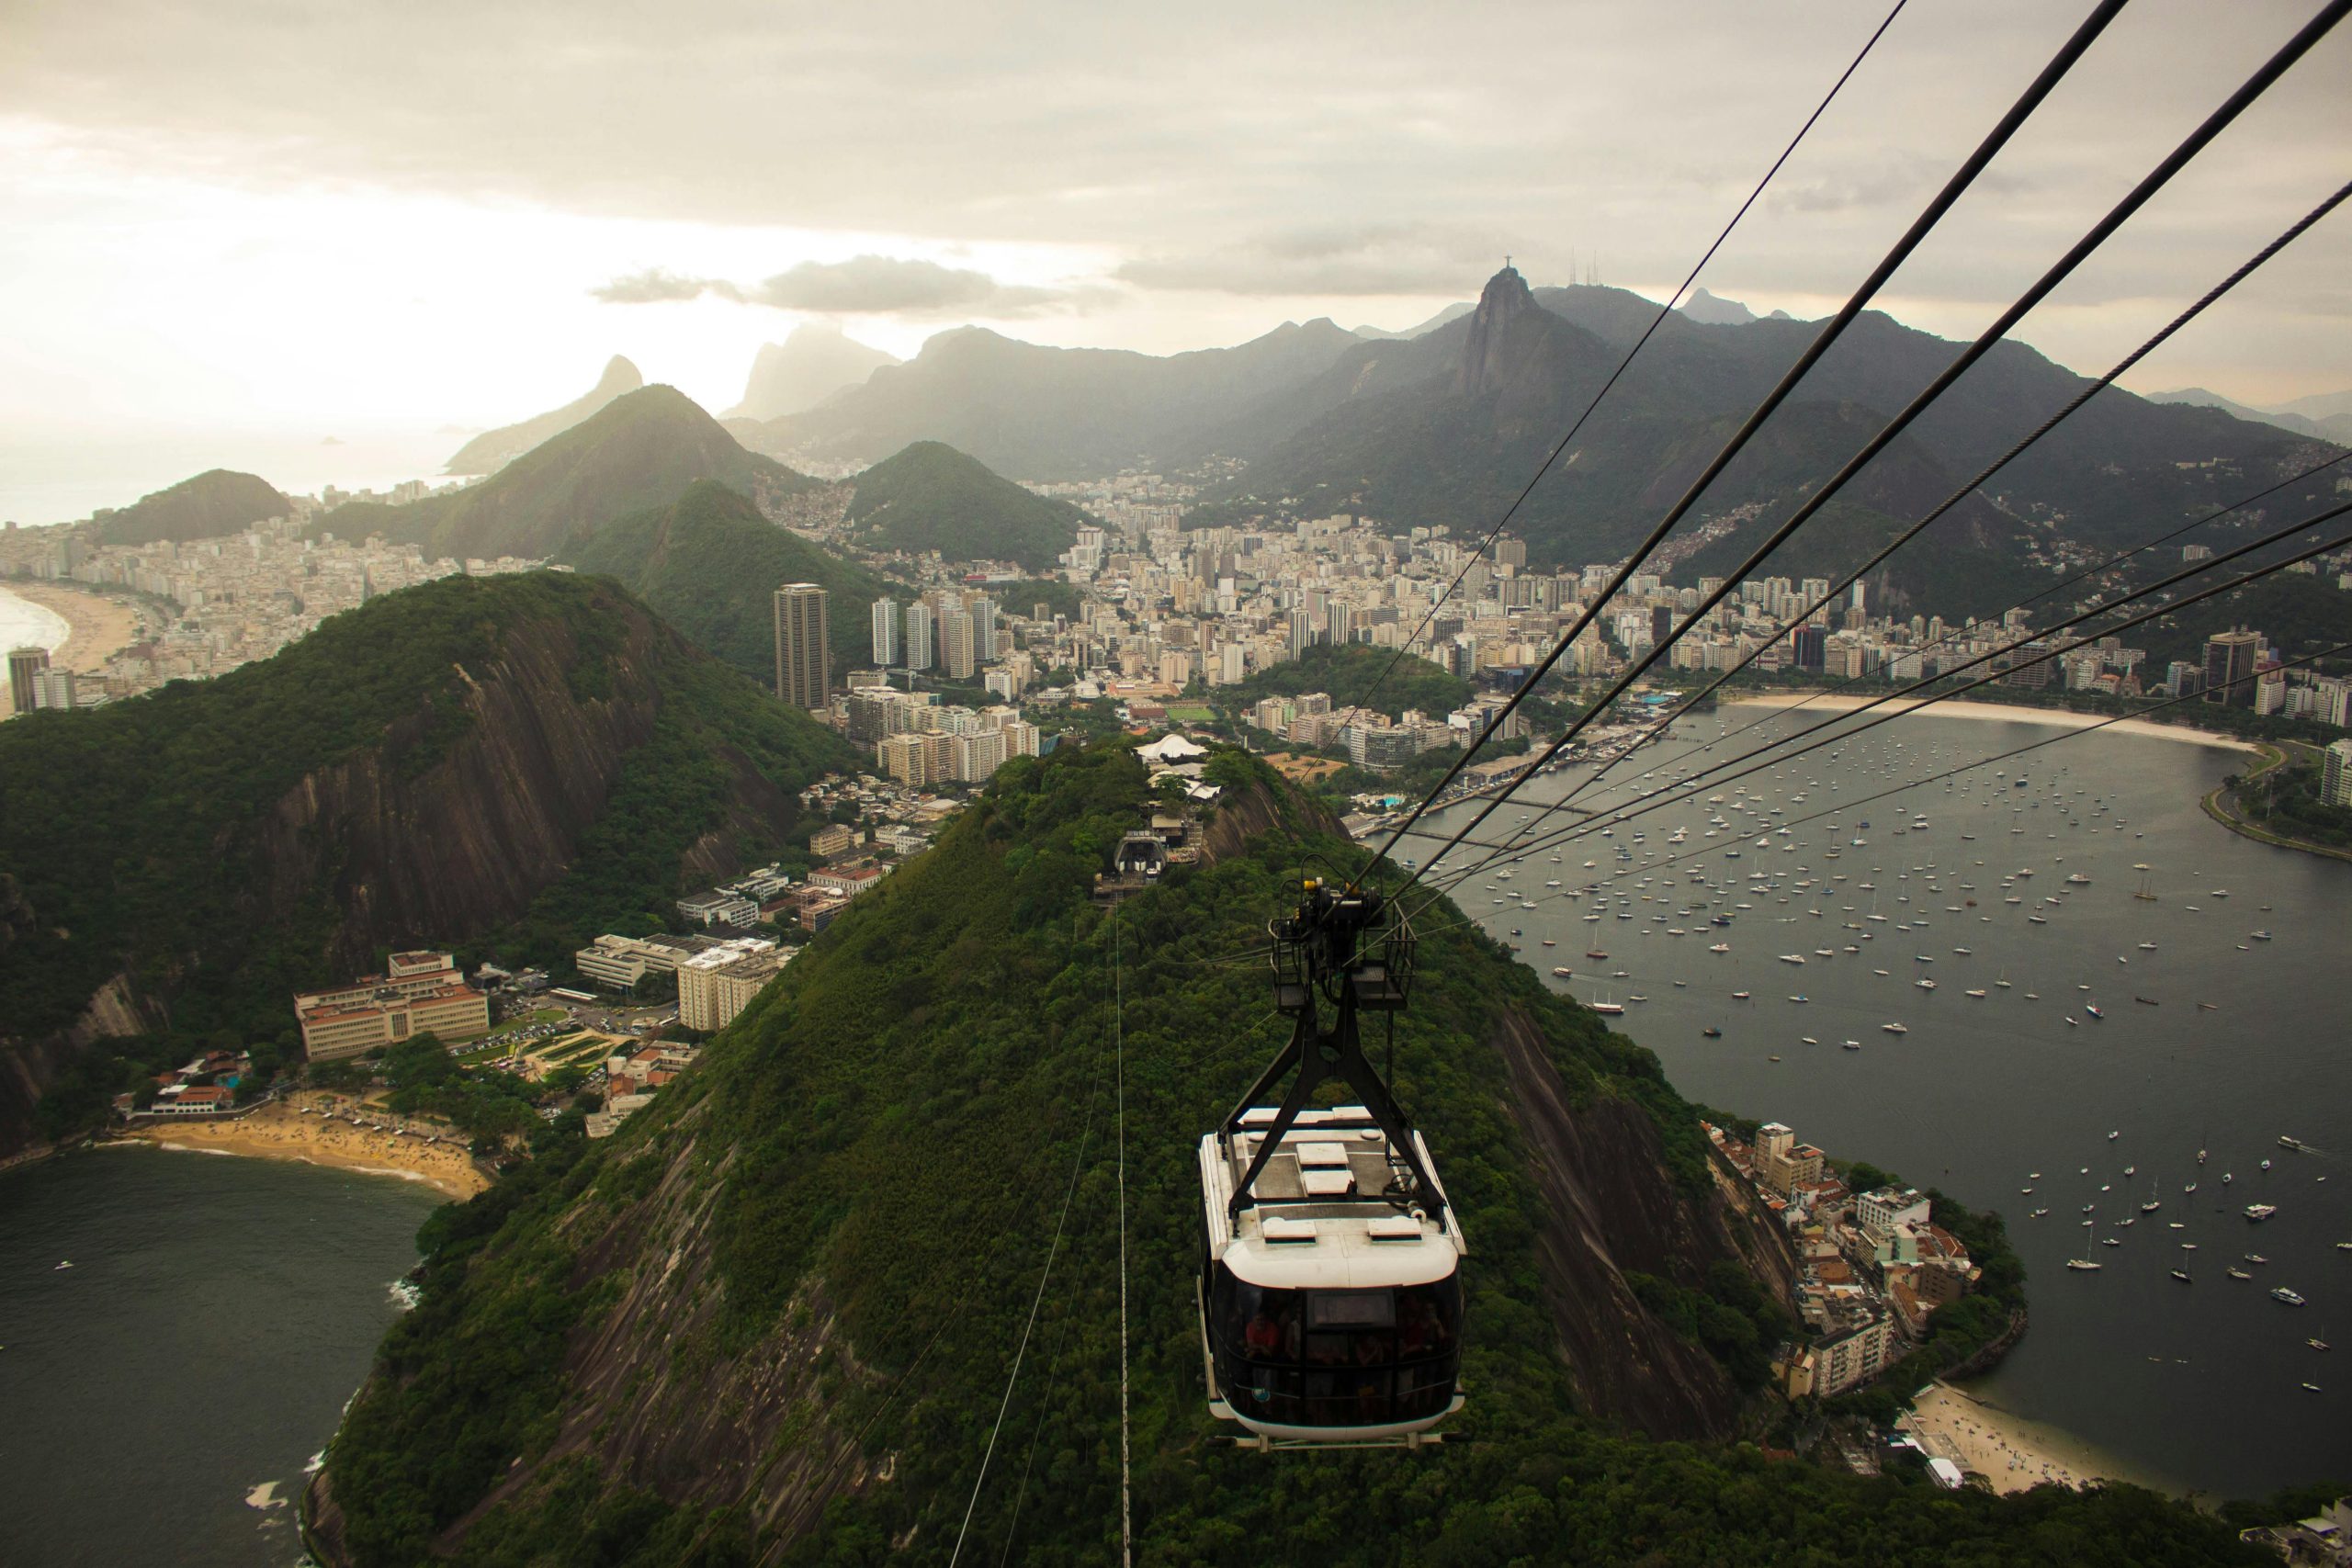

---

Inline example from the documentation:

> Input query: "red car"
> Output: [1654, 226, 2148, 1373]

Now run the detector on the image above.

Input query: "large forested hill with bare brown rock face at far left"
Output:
[0, 571, 849, 1152]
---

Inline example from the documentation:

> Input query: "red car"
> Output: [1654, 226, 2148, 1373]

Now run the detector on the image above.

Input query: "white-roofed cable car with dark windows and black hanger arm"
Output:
[1200, 879, 1467, 1450]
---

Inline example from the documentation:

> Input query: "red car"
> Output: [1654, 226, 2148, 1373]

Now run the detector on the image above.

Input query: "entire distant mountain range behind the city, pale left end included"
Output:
[691, 270, 2352, 609]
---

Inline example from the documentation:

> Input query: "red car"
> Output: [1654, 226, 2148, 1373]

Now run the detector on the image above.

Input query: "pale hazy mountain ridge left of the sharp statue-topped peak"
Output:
[752, 320, 1357, 479]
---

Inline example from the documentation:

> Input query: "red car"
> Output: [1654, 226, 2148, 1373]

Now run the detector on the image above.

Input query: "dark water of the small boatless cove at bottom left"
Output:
[0, 1145, 440, 1568]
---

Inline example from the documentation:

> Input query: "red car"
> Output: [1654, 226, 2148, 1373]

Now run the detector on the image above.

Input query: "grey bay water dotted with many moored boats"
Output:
[1399, 705, 2352, 1495]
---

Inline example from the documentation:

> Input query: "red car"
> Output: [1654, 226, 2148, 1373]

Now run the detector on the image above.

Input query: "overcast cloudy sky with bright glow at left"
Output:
[0, 0, 2352, 495]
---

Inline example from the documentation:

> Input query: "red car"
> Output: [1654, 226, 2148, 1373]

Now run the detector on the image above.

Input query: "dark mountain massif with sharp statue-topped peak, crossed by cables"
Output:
[1221, 270, 2319, 597]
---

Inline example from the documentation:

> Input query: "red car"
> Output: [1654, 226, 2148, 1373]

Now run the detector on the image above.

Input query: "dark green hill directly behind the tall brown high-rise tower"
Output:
[562, 479, 903, 684]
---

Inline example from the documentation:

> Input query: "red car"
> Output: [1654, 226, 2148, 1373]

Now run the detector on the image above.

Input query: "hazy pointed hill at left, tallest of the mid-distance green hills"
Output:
[320, 386, 819, 559]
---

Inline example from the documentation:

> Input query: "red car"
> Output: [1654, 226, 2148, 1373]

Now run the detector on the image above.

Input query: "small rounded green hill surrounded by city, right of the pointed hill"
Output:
[849, 442, 1087, 571]
